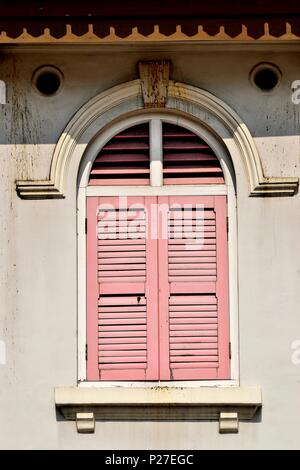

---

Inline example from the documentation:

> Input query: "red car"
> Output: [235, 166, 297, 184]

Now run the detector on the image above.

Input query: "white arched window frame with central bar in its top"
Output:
[78, 112, 239, 387]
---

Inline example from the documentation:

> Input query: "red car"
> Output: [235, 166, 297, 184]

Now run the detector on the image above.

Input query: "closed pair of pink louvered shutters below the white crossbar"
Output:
[87, 196, 229, 380]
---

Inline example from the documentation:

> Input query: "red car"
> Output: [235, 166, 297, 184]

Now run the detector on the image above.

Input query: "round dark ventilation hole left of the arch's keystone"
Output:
[32, 66, 63, 96]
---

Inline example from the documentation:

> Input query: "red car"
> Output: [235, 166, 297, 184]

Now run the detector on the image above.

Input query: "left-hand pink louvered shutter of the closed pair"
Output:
[87, 197, 158, 380]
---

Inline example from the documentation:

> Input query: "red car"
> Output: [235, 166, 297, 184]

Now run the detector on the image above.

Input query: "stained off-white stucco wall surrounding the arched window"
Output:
[0, 46, 300, 449]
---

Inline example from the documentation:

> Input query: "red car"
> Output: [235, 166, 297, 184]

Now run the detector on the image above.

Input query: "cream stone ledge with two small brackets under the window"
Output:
[55, 386, 262, 432]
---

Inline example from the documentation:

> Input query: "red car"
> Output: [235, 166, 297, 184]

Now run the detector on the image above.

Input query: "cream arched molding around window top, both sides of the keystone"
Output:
[17, 80, 298, 199]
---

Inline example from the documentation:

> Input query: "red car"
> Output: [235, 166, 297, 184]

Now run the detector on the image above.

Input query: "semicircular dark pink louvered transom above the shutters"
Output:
[89, 121, 224, 186]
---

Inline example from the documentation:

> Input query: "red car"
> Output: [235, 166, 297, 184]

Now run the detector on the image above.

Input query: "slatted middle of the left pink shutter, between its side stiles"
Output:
[98, 197, 148, 380]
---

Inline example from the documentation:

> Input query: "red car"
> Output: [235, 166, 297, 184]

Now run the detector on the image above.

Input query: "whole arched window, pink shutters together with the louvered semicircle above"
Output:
[79, 117, 237, 381]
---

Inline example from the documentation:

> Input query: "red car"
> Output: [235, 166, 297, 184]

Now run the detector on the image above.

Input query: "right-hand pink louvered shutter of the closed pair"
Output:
[158, 196, 229, 380]
